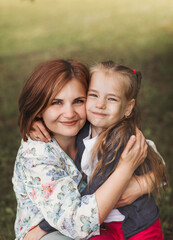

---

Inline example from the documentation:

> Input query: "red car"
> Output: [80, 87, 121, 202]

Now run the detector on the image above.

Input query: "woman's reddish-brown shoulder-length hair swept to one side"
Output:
[18, 59, 90, 141]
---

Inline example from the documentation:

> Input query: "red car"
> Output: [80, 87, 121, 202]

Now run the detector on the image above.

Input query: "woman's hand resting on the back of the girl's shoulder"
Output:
[120, 129, 148, 171]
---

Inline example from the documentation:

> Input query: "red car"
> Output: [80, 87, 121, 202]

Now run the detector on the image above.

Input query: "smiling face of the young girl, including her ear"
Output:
[86, 71, 134, 134]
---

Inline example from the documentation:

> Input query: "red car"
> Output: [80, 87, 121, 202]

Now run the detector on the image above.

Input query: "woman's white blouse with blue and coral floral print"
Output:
[12, 138, 100, 240]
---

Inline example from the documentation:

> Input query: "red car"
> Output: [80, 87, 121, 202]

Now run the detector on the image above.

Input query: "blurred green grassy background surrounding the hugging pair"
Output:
[0, 0, 173, 240]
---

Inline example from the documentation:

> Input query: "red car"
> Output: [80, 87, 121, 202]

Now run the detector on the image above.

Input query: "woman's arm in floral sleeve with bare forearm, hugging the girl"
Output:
[18, 128, 146, 238]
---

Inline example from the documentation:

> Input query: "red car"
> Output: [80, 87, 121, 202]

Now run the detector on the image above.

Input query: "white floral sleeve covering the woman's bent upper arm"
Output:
[19, 140, 99, 239]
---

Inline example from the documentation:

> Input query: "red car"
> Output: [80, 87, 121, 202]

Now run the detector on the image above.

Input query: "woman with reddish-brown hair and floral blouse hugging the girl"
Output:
[13, 59, 146, 240]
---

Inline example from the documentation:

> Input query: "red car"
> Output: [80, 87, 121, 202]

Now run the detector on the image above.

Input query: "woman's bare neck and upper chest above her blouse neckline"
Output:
[54, 136, 77, 161]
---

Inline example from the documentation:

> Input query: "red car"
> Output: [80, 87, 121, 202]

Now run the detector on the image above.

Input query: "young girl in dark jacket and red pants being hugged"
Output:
[81, 61, 167, 240]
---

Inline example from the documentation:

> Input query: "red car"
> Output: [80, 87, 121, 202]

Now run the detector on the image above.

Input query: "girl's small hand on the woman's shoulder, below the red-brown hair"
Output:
[29, 121, 51, 142]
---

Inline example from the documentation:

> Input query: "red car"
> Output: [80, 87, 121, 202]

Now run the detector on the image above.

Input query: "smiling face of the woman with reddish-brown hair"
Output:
[42, 79, 86, 141]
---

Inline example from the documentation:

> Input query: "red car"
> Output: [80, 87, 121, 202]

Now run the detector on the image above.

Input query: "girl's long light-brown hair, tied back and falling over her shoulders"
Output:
[90, 61, 167, 193]
